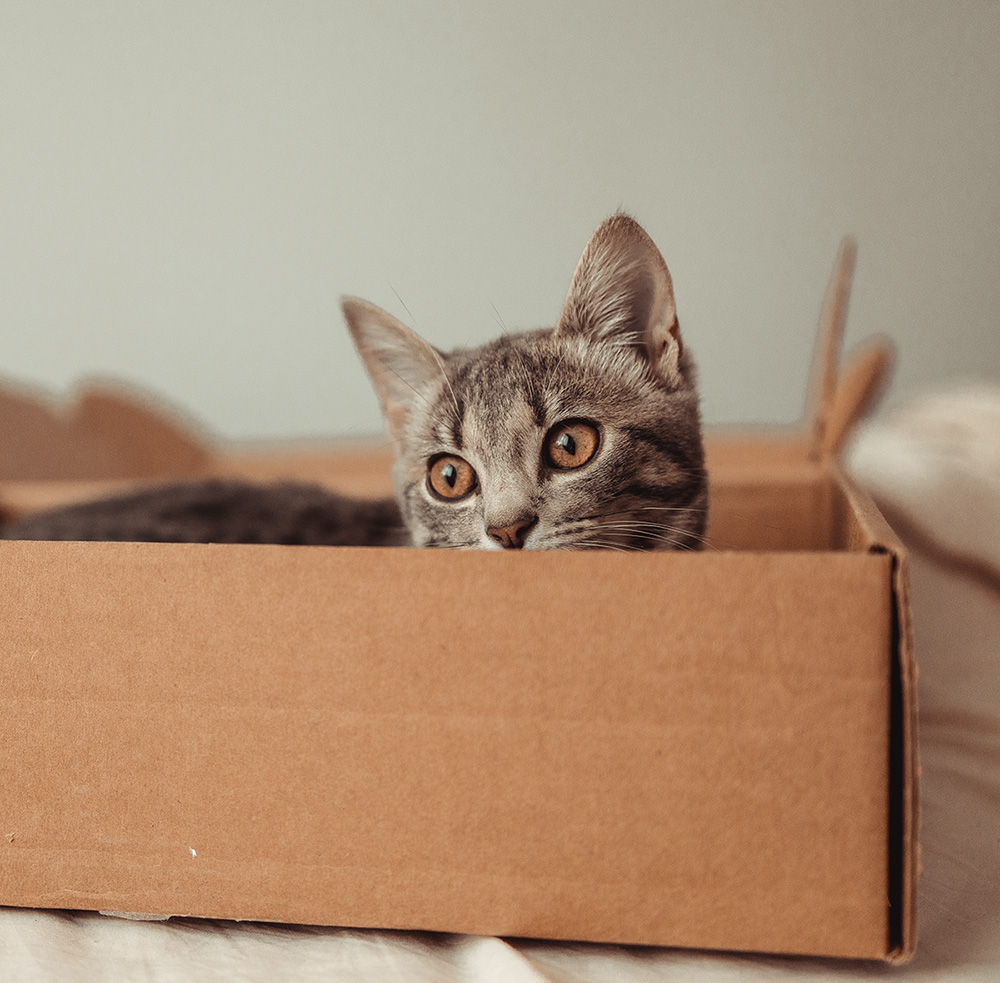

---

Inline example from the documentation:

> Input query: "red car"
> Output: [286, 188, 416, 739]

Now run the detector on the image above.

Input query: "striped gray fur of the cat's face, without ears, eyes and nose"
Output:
[348, 330, 707, 549]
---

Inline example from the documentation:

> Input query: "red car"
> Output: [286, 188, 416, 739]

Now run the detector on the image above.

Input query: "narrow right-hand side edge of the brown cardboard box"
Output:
[828, 460, 920, 964]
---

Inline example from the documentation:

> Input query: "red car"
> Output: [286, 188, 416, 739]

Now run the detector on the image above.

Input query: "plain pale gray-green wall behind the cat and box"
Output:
[0, 0, 1000, 437]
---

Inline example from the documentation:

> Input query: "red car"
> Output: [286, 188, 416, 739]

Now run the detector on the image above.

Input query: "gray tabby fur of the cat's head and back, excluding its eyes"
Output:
[2, 215, 708, 550]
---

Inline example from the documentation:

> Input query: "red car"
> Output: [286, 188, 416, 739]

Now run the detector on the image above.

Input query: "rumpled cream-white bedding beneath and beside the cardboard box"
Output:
[0, 391, 1000, 983]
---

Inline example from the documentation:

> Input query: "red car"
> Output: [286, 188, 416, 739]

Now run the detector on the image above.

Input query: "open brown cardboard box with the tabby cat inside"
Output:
[0, 246, 917, 960]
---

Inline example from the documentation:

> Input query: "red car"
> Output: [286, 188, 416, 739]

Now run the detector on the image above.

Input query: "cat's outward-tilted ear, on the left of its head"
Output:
[340, 297, 443, 438]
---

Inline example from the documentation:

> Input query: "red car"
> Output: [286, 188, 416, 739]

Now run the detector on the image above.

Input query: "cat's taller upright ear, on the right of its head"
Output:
[556, 214, 684, 385]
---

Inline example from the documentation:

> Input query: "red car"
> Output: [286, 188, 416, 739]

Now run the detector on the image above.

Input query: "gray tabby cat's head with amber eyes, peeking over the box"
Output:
[343, 215, 707, 549]
